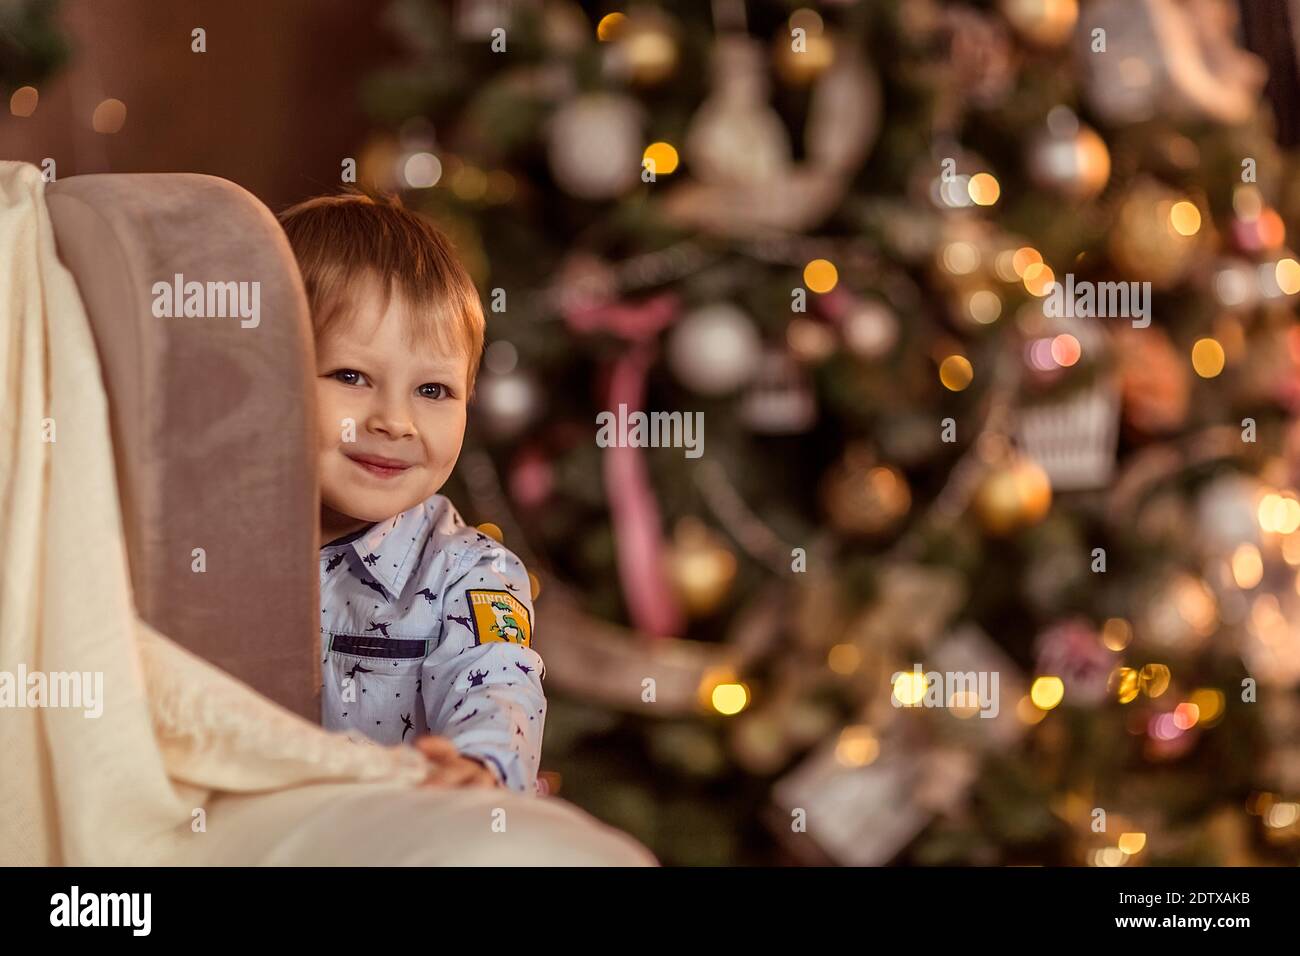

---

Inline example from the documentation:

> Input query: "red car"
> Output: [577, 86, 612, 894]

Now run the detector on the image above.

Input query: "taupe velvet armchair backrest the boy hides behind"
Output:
[47, 173, 320, 722]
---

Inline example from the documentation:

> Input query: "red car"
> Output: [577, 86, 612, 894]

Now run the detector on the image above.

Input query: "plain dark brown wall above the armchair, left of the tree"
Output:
[0, 0, 391, 209]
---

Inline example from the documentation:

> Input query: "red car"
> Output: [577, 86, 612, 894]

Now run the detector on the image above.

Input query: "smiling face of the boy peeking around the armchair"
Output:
[316, 284, 469, 544]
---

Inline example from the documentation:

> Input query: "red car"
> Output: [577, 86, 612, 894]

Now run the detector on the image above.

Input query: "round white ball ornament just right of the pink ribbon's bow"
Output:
[668, 302, 763, 395]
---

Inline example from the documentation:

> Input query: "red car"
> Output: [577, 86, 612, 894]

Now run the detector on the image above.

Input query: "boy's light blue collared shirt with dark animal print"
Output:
[321, 494, 546, 793]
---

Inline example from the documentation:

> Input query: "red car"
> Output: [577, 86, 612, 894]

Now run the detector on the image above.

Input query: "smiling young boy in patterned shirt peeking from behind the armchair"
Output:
[280, 194, 546, 793]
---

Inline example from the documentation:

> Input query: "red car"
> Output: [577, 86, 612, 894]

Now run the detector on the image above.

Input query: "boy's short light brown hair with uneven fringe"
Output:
[278, 193, 484, 398]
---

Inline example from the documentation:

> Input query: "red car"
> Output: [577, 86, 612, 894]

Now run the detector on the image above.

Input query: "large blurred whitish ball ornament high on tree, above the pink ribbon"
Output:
[547, 94, 645, 200]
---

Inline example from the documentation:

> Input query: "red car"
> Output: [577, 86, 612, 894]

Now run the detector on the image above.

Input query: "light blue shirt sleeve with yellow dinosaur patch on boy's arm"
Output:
[421, 545, 546, 793]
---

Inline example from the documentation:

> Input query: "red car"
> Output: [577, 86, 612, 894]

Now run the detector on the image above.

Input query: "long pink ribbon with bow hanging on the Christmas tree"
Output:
[564, 293, 685, 637]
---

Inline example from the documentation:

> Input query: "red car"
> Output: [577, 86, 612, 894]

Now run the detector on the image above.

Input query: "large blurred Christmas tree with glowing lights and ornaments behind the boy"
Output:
[359, 0, 1300, 865]
